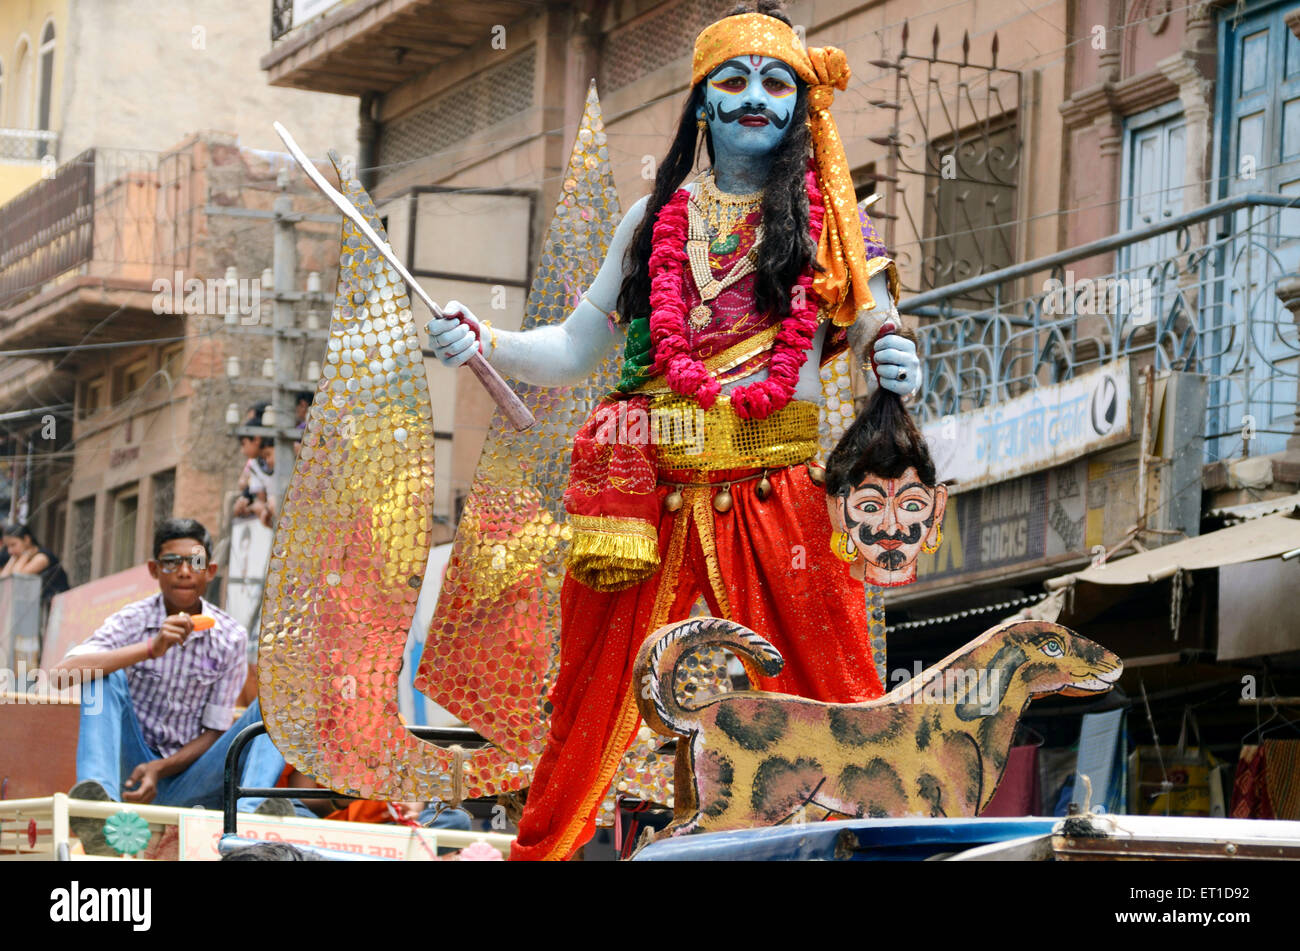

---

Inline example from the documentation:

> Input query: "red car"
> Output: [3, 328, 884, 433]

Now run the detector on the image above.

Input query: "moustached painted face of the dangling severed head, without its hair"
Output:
[827, 468, 948, 587]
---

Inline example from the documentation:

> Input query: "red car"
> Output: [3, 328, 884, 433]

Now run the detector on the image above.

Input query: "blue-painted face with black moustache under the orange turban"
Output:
[705, 56, 797, 157]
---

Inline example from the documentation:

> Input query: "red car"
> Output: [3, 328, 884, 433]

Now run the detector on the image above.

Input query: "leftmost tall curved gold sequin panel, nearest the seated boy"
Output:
[259, 155, 451, 800]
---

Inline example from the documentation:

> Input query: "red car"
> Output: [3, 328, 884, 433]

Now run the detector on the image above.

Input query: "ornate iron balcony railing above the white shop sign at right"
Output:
[900, 194, 1300, 460]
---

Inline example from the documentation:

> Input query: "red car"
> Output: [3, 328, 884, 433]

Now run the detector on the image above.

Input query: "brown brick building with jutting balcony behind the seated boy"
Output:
[0, 133, 338, 585]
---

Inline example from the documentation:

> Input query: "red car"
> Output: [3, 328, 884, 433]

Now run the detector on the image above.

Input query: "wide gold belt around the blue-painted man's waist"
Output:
[650, 394, 820, 472]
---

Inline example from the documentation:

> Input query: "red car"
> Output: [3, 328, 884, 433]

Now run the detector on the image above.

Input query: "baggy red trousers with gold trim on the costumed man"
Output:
[511, 452, 883, 860]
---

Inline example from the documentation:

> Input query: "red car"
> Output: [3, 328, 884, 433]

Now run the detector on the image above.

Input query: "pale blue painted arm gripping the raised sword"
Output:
[426, 199, 647, 386]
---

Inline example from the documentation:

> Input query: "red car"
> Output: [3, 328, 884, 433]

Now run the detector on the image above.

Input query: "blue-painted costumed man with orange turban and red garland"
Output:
[428, 3, 920, 859]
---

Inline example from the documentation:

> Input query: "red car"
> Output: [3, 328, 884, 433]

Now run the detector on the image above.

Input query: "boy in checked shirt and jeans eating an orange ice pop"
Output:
[52, 518, 291, 855]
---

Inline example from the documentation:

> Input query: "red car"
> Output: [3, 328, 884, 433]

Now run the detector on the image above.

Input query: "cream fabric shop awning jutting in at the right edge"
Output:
[1045, 507, 1300, 591]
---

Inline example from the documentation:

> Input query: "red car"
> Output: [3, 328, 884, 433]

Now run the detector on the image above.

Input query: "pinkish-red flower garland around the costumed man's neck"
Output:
[650, 169, 826, 420]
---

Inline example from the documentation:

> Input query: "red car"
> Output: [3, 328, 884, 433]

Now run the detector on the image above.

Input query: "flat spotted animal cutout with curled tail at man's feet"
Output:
[634, 617, 1123, 835]
